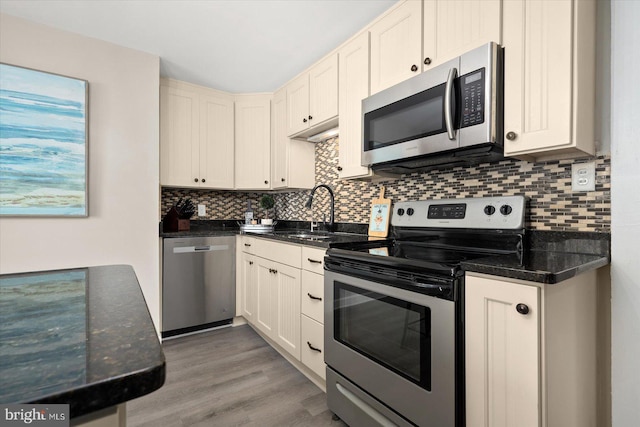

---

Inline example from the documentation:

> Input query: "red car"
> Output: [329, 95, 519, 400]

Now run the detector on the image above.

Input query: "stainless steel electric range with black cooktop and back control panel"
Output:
[325, 196, 526, 427]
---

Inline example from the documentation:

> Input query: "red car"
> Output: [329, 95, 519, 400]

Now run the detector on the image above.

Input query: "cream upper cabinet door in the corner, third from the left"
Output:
[235, 96, 271, 190]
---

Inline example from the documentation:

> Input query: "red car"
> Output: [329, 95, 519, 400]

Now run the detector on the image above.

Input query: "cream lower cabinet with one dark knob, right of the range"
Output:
[465, 271, 598, 427]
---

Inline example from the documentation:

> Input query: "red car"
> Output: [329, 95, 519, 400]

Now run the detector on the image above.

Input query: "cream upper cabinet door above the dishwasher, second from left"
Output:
[200, 94, 234, 189]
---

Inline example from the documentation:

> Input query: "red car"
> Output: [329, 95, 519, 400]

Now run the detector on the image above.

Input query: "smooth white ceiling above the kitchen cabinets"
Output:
[0, 0, 398, 93]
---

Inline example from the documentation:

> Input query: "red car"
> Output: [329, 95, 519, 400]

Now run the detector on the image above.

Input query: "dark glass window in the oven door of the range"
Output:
[334, 282, 431, 390]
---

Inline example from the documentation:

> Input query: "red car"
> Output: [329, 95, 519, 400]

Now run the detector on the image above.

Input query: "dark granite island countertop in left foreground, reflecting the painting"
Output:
[0, 265, 165, 418]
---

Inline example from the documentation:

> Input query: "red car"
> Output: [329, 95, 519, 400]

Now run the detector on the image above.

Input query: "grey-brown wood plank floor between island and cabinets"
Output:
[127, 325, 346, 427]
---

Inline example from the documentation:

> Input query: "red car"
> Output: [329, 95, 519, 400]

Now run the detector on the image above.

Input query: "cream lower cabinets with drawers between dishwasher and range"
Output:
[237, 236, 325, 388]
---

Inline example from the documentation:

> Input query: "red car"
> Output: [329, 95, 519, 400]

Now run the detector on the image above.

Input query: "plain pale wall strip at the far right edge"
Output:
[611, 0, 640, 427]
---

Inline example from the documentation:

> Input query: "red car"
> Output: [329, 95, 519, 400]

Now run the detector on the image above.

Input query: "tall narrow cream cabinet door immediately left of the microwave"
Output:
[338, 33, 371, 178]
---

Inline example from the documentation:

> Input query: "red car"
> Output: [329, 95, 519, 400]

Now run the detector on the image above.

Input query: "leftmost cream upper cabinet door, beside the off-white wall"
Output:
[160, 85, 200, 187]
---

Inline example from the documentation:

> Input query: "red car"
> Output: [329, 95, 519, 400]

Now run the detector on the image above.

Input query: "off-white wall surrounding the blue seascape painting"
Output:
[0, 14, 160, 326]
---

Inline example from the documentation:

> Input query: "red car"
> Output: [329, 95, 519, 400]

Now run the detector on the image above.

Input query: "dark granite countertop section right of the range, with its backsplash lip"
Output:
[462, 230, 611, 284]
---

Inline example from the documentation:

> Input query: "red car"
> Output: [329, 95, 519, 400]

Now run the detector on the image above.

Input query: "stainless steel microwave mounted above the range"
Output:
[362, 43, 503, 173]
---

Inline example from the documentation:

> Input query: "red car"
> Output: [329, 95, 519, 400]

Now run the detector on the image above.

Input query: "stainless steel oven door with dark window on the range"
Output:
[325, 271, 456, 426]
